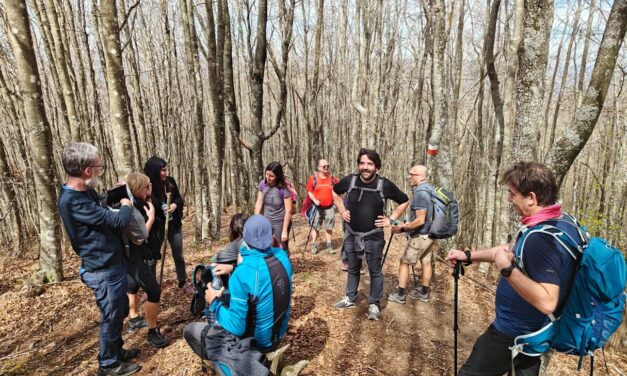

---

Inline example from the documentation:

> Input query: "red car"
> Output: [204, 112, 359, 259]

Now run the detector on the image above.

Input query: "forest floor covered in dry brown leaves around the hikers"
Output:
[0, 210, 627, 375]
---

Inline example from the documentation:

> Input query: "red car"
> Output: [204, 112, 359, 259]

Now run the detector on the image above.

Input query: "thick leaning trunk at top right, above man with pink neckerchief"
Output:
[547, 0, 627, 185]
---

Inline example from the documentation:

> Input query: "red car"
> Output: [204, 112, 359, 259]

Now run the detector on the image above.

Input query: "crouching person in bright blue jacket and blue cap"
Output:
[183, 215, 292, 375]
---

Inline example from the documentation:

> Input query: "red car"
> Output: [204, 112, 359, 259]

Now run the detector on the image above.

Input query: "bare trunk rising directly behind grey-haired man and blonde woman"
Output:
[98, 0, 133, 179]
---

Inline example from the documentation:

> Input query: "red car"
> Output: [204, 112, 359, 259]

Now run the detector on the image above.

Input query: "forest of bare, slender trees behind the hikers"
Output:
[0, 0, 627, 296]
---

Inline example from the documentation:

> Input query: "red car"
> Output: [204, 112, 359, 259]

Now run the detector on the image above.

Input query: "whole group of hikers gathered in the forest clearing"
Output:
[58, 143, 620, 375]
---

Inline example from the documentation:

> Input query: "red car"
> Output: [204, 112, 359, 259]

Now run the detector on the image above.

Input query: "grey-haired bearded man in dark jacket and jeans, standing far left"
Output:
[57, 142, 139, 375]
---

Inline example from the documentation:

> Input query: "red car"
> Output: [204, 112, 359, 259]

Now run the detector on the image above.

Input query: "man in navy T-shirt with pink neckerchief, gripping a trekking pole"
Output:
[446, 162, 582, 376]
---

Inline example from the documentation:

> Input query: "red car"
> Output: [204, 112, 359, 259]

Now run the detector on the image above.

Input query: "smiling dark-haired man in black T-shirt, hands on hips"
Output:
[333, 149, 409, 320]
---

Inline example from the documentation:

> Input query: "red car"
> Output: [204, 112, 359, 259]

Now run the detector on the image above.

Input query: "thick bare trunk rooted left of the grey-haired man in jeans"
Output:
[5, 0, 63, 284]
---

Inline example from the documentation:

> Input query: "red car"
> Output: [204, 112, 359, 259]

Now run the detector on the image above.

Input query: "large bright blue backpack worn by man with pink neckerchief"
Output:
[512, 215, 627, 373]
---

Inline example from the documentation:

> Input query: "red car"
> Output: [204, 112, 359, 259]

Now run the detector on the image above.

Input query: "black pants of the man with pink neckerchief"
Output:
[457, 325, 540, 376]
